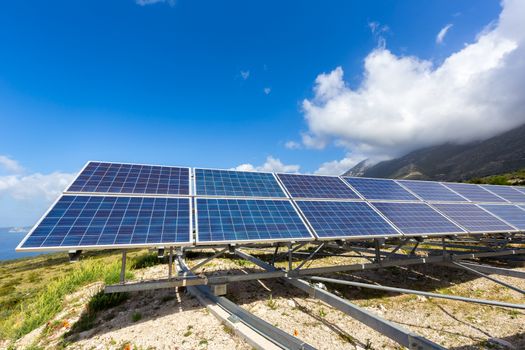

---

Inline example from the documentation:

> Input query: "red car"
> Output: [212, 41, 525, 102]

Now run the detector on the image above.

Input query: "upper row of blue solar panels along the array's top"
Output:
[67, 162, 525, 204]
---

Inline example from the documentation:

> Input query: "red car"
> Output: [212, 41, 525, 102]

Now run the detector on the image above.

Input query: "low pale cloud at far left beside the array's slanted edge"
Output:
[0, 156, 74, 227]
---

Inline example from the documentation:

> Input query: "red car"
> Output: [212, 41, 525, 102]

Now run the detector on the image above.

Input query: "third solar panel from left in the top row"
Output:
[277, 174, 359, 199]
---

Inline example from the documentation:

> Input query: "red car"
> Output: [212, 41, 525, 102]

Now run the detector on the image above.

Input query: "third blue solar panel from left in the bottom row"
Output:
[296, 201, 400, 238]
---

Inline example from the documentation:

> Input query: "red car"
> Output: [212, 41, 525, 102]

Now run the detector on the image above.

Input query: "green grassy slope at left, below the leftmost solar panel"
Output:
[0, 252, 132, 339]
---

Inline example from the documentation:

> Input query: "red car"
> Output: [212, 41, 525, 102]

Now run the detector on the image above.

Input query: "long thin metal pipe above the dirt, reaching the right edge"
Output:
[305, 276, 525, 310]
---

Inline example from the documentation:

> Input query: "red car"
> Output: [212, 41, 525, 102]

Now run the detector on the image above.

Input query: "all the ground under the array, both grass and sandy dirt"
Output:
[0, 243, 525, 349]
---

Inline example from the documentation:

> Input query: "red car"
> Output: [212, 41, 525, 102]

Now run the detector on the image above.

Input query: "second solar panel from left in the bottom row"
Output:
[195, 198, 312, 243]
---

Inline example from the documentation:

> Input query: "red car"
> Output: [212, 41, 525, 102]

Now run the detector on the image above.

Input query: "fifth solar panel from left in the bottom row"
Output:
[434, 204, 515, 233]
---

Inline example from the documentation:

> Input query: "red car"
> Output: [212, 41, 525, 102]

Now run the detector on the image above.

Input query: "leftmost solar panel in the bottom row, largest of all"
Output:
[19, 195, 191, 250]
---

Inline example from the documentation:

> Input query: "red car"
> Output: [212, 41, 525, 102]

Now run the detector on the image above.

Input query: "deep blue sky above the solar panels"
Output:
[0, 0, 520, 226]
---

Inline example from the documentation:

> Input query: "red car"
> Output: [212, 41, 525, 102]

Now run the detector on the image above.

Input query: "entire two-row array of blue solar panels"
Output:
[18, 162, 525, 250]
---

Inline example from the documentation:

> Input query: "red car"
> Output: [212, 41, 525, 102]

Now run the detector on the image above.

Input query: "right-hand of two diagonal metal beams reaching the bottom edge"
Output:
[236, 250, 445, 350]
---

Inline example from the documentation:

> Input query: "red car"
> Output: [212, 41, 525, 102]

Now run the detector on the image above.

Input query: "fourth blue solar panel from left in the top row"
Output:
[344, 177, 418, 201]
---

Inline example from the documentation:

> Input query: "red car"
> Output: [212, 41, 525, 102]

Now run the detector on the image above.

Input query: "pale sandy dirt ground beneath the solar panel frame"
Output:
[11, 247, 525, 349]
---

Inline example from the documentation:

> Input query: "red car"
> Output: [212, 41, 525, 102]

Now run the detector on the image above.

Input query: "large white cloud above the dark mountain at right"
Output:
[302, 0, 525, 171]
